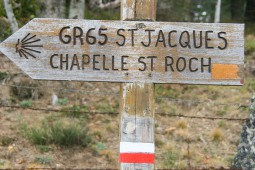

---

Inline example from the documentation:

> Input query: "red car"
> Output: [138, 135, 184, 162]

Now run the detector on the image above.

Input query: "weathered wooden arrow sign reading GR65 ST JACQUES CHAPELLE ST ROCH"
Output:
[0, 19, 244, 85]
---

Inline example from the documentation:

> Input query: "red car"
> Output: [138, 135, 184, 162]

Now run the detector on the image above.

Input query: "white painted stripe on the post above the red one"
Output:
[120, 142, 155, 153]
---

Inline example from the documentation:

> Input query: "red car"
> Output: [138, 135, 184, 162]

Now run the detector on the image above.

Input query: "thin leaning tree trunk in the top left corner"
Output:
[4, 0, 19, 33]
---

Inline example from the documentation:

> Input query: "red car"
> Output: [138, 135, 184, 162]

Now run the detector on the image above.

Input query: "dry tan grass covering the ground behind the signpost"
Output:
[0, 43, 255, 169]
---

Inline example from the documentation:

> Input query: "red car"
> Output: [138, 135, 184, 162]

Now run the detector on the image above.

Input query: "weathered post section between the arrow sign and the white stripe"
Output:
[120, 83, 154, 143]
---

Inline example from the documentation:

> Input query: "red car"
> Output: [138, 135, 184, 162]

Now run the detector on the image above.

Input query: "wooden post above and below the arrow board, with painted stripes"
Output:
[120, 0, 156, 170]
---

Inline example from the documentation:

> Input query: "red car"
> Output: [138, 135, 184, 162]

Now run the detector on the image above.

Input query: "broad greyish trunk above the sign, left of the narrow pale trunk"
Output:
[38, 0, 66, 18]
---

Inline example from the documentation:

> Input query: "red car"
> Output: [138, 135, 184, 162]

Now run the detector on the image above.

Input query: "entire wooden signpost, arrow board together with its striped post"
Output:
[0, 0, 244, 170]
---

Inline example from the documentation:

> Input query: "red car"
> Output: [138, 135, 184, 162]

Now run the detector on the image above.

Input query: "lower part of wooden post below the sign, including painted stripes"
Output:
[120, 83, 155, 170]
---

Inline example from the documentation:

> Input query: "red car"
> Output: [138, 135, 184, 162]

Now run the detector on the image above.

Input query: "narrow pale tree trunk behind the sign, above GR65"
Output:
[69, 0, 85, 19]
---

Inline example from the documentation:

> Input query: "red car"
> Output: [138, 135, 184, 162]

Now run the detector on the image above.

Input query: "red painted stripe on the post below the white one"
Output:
[120, 153, 155, 164]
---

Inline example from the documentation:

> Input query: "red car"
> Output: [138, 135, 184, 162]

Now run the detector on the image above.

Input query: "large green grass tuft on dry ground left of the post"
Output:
[21, 117, 91, 147]
